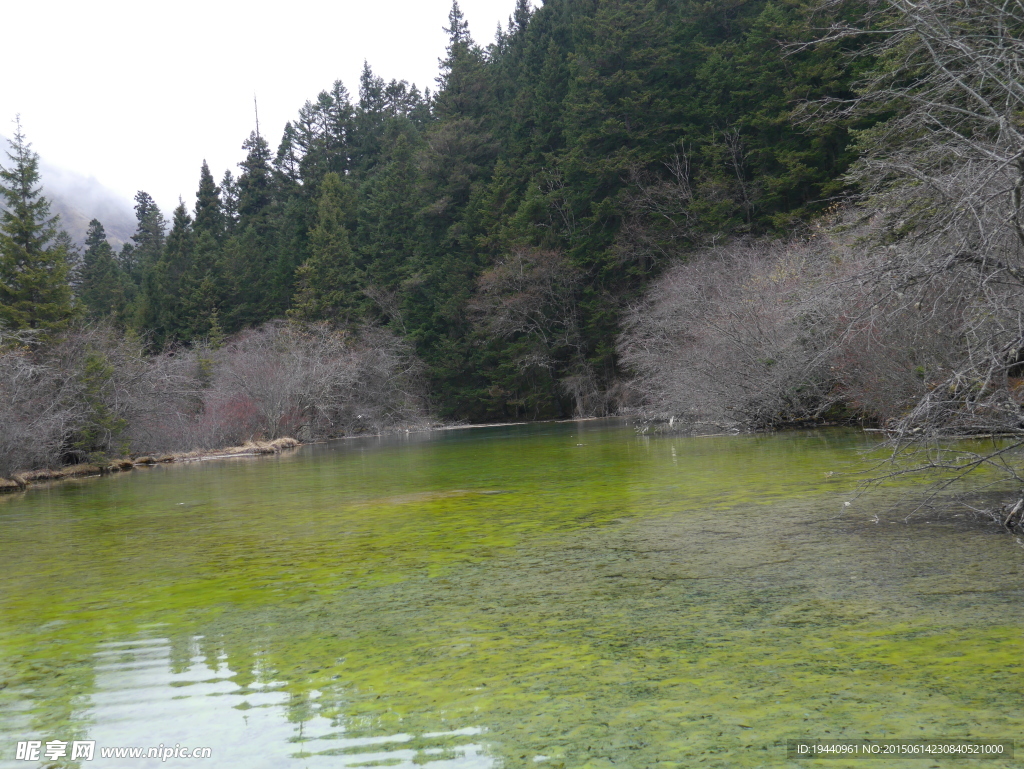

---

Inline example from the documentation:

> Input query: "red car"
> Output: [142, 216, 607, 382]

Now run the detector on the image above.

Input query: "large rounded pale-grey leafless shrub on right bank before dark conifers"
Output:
[618, 239, 842, 428]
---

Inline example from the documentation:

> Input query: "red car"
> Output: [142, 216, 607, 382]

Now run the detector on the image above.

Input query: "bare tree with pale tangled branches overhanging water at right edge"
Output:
[807, 0, 1024, 499]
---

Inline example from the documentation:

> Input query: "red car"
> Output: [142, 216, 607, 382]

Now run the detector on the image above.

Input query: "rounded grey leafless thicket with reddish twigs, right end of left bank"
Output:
[151, 323, 425, 447]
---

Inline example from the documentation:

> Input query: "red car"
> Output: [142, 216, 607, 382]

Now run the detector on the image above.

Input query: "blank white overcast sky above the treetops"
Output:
[6, 0, 540, 218]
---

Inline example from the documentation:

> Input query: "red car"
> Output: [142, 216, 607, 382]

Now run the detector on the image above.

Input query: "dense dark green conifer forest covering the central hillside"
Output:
[0, 0, 853, 420]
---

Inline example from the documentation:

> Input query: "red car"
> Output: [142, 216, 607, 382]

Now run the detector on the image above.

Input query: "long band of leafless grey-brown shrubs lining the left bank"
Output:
[0, 323, 426, 476]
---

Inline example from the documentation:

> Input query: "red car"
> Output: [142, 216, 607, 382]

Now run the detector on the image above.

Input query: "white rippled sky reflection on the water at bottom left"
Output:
[80, 637, 494, 769]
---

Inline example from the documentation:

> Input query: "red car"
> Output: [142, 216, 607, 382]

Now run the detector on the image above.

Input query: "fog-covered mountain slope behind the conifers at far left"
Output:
[0, 136, 135, 248]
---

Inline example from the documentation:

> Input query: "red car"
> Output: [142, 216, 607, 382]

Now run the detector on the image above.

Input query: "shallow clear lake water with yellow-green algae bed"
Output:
[0, 422, 1024, 769]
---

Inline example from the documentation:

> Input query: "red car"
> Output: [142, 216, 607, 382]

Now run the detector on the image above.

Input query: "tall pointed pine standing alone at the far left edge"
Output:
[0, 121, 73, 333]
